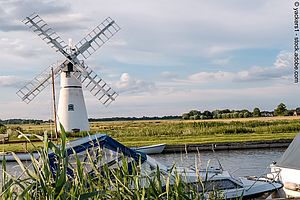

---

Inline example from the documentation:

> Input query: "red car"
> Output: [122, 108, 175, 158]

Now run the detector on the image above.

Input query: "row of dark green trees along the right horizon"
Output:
[181, 103, 300, 120]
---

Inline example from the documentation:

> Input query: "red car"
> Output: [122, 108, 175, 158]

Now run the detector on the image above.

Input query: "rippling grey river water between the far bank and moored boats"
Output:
[0, 148, 285, 182]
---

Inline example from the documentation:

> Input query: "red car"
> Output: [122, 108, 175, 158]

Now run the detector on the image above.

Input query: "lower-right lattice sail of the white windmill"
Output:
[74, 66, 118, 106]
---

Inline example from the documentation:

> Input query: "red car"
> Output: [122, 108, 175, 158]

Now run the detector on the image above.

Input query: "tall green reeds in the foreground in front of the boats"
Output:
[0, 130, 222, 200]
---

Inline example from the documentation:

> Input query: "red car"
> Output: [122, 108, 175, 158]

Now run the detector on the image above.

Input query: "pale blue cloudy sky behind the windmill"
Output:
[0, 0, 300, 120]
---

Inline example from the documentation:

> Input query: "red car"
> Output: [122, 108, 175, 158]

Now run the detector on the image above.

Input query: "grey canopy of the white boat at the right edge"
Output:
[276, 134, 300, 169]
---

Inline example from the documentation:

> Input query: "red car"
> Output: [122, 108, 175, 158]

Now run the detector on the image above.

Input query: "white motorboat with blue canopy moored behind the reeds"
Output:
[48, 134, 283, 199]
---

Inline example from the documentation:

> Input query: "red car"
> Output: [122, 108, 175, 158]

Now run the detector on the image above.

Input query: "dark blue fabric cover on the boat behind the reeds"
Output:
[48, 134, 147, 172]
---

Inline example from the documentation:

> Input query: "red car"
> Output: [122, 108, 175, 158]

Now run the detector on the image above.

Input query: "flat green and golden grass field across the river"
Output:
[0, 117, 300, 151]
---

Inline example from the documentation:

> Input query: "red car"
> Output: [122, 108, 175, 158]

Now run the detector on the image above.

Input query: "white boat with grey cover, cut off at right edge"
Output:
[268, 134, 300, 198]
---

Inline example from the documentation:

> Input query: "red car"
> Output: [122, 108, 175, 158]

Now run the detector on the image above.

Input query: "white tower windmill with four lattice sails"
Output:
[17, 13, 120, 132]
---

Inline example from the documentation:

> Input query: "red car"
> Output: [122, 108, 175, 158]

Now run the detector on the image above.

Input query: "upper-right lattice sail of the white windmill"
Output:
[75, 17, 121, 59]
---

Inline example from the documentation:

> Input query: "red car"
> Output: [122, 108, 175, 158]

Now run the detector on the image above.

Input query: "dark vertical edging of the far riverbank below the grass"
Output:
[162, 139, 292, 153]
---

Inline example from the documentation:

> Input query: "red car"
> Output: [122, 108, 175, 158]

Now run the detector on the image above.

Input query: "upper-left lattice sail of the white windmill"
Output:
[22, 13, 68, 56]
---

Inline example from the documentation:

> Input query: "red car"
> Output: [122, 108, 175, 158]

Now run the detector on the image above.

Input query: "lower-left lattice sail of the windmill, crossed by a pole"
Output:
[17, 63, 64, 104]
